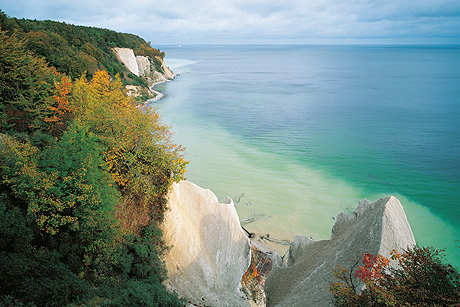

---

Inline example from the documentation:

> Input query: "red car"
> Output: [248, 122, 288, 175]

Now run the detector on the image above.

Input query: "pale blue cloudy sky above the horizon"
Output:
[0, 0, 460, 46]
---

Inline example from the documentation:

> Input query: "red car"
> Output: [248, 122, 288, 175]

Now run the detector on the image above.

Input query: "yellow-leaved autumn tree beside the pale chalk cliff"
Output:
[69, 71, 187, 232]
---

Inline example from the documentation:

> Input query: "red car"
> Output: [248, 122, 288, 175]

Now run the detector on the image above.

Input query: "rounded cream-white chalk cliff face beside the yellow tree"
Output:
[163, 181, 251, 306]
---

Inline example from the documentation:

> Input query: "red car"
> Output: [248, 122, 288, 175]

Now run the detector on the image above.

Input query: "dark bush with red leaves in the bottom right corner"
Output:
[329, 246, 460, 306]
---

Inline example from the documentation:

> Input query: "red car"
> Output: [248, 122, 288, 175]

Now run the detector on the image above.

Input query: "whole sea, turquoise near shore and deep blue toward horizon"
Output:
[153, 46, 460, 266]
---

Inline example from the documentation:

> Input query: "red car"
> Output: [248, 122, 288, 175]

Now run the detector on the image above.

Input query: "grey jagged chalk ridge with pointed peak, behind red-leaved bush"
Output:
[265, 196, 415, 307]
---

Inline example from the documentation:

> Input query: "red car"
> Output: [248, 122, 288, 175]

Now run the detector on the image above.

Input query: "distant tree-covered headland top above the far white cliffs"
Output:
[0, 10, 165, 85]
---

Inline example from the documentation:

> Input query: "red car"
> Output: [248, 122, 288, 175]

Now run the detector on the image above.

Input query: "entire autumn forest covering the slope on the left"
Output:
[0, 11, 187, 306]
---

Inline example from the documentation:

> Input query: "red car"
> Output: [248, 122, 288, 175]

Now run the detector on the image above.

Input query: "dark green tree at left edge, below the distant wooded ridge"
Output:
[0, 31, 58, 133]
